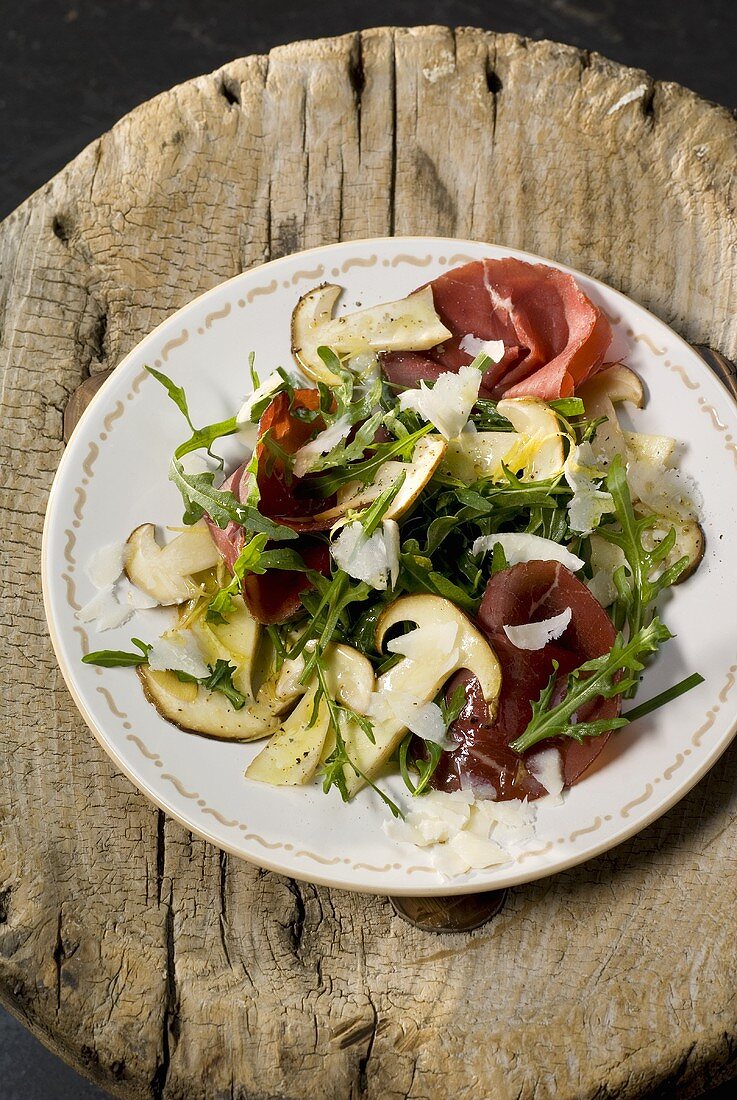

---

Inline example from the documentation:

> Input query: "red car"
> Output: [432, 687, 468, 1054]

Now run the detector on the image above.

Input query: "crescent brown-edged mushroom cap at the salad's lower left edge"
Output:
[136, 664, 279, 741]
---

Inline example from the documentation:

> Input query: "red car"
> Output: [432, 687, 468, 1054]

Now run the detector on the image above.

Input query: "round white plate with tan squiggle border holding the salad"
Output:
[42, 238, 737, 894]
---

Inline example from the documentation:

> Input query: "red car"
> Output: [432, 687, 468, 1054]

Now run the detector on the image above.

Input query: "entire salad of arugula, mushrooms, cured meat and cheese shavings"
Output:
[78, 257, 704, 875]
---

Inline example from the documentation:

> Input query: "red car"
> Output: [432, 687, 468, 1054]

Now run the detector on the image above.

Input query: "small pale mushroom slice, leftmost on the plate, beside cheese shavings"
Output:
[125, 523, 221, 605]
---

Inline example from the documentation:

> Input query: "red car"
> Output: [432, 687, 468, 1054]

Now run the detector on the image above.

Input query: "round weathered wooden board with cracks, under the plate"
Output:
[0, 28, 737, 1100]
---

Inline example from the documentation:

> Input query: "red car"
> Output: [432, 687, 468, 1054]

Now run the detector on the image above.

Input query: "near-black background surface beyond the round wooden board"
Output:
[0, 0, 737, 1100]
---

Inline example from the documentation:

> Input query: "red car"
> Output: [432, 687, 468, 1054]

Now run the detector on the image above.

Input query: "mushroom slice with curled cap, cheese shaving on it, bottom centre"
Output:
[344, 595, 502, 794]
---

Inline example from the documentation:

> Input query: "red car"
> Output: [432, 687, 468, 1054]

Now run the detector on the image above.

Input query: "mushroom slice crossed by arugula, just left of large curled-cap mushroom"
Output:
[245, 645, 374, 787]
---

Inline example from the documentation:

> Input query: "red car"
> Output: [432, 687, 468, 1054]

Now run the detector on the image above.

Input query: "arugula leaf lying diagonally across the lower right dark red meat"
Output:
[509, 618, 673, 755]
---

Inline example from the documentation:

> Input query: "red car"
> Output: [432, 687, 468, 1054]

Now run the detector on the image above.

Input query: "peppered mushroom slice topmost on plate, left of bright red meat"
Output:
[292, 283, 451, 386]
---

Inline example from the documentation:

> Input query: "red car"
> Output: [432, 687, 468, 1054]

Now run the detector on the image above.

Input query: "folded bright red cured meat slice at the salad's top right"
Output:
[382, 257, 612, 400]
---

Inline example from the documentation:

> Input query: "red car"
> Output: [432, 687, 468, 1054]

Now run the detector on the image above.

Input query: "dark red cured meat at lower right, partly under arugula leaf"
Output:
[433, 561, 620, 801]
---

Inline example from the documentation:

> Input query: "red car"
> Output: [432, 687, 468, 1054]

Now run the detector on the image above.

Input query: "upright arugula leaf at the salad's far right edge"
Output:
[596, 454, 689, 635]
